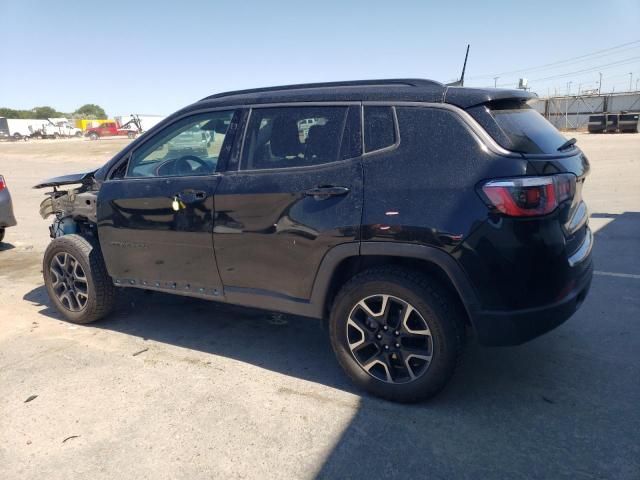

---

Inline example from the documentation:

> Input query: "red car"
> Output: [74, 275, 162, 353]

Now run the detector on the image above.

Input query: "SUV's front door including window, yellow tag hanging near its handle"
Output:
[98, 110, 239, 296]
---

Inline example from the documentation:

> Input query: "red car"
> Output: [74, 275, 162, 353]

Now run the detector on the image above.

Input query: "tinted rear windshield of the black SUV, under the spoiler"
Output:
[474, 102, 567, 153]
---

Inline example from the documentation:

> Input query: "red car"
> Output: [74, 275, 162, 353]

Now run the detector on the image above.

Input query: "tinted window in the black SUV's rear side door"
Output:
[241, 106, 359, 170]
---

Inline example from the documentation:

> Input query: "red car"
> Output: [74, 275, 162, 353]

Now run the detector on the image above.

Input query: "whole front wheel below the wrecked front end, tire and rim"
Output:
[42, 235, 115, 323]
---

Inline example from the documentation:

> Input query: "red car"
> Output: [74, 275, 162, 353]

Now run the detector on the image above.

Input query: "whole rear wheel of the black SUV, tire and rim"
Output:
[329, 268, 464, 402]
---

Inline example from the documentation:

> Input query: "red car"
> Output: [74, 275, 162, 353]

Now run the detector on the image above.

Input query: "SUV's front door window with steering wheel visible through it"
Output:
[127, 110, 234, 177]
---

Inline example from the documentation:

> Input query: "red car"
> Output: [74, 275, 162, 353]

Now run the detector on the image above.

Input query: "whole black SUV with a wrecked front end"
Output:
[37, 79, 593, 401]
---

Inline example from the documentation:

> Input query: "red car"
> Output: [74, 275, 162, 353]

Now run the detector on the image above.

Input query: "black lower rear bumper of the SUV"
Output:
[472, 256, 593, 346]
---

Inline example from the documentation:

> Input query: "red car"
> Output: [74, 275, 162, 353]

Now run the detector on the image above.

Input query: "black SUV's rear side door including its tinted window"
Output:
[214, 105, 363, 303]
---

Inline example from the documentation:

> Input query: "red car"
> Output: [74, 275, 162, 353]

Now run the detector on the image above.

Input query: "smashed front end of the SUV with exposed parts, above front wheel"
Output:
[33, 171, 100, 238]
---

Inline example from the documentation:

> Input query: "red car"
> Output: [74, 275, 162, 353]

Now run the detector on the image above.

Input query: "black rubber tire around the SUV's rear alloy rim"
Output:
[329, 267, 465, 402]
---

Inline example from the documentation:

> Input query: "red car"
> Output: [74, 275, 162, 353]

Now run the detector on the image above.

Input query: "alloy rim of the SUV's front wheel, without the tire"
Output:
[49, 252, 89, 312]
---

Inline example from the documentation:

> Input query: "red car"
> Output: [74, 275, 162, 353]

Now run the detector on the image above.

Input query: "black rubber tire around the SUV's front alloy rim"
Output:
[42, 235, 116, 324]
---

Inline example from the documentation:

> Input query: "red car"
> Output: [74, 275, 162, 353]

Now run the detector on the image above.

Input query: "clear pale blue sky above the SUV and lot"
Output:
[0, 0, 640, 115]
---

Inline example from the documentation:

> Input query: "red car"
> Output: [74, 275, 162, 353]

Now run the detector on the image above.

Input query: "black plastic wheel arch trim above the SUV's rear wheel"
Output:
[311, 242, 479, 322]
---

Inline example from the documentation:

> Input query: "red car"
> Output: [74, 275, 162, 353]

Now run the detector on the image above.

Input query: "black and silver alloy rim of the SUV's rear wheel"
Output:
[346, 294, 433, 383]
